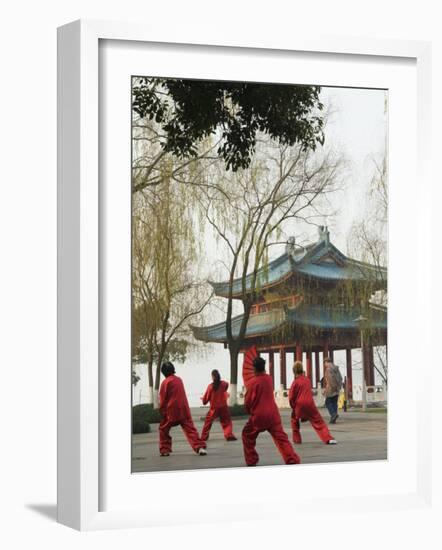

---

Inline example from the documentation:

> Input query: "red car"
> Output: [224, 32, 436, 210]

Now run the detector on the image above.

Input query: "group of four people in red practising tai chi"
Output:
[159, 357, 337, 466]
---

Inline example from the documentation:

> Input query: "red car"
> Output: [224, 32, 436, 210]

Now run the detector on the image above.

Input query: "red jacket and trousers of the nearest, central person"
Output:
[242, 372, 301, 466]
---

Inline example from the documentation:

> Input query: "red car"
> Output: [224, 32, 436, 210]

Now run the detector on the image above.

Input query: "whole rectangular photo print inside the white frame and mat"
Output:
[131, 75, 388, 473]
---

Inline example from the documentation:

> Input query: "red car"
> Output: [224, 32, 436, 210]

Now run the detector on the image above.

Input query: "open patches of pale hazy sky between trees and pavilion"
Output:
[133, 88, 387, 406]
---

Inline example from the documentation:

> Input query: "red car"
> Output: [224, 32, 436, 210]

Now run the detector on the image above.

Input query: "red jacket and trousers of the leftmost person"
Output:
[159, 374, 206, 453]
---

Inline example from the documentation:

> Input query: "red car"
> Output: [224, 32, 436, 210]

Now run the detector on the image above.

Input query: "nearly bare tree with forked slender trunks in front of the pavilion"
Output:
[199, 138, 340, 404]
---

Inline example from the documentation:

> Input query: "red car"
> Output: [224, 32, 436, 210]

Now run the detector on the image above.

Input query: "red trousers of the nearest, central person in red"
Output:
[242, 418, 301, 466]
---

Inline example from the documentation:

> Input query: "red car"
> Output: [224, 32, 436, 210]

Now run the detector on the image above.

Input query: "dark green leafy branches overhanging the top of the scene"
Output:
[132, 77, 324, 171]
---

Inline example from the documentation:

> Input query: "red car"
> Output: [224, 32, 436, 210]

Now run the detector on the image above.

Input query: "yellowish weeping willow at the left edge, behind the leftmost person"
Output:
[132, 78, 218, 404]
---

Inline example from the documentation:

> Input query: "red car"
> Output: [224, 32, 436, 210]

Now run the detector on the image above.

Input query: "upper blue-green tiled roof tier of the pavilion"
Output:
[211, 228, 387, 298]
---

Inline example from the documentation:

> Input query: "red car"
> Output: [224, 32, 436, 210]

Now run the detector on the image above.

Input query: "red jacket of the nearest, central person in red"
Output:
[244, 372, 281, 430]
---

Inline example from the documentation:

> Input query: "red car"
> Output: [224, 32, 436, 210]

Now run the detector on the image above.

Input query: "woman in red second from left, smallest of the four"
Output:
[201, 369, 236, 441]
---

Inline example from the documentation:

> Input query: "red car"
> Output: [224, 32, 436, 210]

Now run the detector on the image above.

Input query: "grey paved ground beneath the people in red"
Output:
[132, 408, 387, 472]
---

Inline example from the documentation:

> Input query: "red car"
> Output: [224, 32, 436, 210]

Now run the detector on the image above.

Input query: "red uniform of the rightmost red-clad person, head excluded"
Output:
[289, 374, 333, 443]
